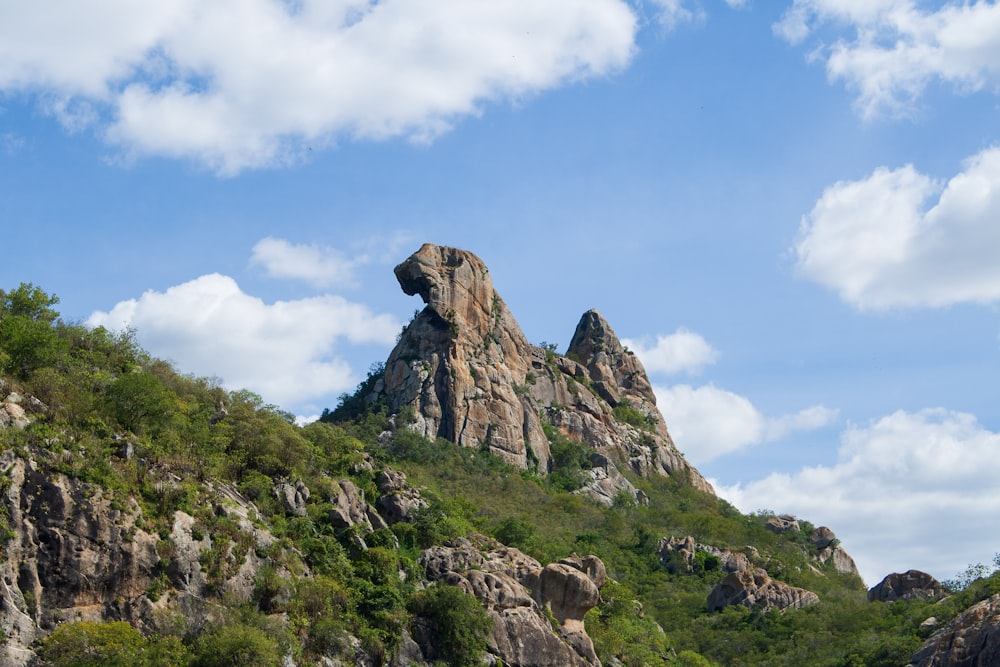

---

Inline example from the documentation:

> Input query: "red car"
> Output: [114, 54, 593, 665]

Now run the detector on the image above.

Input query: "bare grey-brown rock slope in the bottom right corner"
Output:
[911, 594, 1000, 667]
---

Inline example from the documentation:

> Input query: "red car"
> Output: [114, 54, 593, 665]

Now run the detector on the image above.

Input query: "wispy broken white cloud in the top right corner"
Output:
[774, 0, 1000, 117]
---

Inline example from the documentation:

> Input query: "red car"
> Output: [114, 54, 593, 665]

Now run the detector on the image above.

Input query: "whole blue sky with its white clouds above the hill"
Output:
[0, 0, 1000, 585]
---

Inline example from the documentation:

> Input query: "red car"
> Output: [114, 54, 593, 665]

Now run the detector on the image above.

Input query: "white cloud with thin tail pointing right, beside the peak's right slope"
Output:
[653, 384, 838, 465]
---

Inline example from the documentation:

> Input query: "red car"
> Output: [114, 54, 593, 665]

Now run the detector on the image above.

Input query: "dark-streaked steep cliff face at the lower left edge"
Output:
[0, 451, 290, 667]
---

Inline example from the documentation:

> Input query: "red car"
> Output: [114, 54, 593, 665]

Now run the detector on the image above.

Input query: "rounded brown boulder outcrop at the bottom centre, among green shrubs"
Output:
[420, 537, 607, 667]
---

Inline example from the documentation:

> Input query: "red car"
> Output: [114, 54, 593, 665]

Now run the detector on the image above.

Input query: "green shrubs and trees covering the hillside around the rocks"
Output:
[0, 284, 1000, 667]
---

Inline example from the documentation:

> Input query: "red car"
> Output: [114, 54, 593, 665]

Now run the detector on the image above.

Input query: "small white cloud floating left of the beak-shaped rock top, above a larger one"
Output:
[250, 236, 370, 287]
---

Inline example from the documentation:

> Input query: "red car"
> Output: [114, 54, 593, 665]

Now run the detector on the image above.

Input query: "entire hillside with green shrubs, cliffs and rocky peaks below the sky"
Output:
[0, 258, 1000, 666]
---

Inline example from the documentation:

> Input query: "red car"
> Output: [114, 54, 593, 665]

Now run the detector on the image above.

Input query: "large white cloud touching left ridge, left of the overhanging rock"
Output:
[87, 274, 401, 409]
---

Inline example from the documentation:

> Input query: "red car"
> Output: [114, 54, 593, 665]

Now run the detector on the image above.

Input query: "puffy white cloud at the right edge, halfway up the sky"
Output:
[794, 147, 1000, 309]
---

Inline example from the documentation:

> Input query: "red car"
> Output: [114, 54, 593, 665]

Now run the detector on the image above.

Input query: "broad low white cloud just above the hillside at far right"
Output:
[716, 409, 1000, 585]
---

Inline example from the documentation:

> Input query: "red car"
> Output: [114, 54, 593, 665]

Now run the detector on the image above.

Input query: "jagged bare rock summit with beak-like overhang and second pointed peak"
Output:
[376, 243, 712, 504]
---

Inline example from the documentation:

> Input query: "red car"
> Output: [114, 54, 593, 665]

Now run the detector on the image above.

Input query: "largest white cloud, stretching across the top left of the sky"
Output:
[0, 0, 637, 174]
